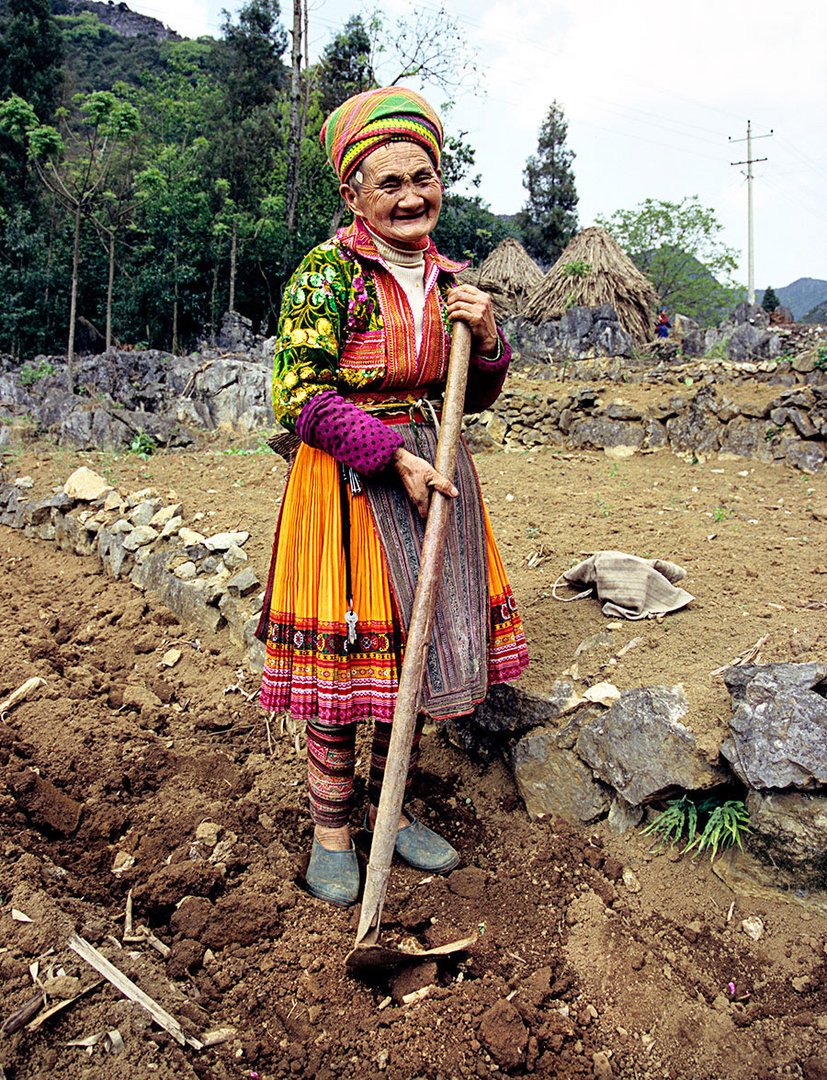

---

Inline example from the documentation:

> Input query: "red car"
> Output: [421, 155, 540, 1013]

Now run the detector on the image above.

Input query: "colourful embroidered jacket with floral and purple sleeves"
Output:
[272, 219, 511, 472]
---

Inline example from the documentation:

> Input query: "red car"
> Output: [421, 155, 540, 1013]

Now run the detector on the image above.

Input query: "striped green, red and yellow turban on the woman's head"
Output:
[321, 86, 443, 183]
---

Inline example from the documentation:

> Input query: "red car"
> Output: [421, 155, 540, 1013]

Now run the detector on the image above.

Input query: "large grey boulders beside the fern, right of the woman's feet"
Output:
[447, 663, 827, 914]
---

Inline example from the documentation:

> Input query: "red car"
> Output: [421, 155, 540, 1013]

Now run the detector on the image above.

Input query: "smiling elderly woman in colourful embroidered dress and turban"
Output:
[259, 87, 528, 905]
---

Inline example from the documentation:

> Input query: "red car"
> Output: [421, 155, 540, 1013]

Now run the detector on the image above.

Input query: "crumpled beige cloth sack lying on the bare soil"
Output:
[560, 551, 694, 619]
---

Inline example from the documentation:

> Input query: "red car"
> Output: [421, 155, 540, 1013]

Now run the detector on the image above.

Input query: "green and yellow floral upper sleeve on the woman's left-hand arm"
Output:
[273, 243, 348, 431]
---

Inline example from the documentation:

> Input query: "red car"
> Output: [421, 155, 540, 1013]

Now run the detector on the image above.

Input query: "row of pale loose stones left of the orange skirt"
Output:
[0, 467, 263, 670]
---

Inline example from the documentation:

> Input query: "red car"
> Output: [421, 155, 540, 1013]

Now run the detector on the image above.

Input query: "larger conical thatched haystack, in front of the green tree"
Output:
[523, 227, 657, 345]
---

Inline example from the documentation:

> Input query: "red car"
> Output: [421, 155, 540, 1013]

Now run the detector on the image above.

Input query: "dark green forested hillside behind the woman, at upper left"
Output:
[0, 0, 514, 359]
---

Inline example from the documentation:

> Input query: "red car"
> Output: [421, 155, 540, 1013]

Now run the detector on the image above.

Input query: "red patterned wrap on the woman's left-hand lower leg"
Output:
[308, 720, 356, 828]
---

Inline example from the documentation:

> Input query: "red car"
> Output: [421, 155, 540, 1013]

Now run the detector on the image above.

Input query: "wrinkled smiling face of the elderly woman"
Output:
[339, 143, 443, 248]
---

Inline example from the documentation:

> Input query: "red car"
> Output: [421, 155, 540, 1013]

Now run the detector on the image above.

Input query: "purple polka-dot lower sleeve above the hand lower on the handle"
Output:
[296, 390, 403, 476]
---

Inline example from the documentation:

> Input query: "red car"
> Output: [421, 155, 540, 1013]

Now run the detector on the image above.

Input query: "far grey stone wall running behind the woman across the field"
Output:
[0, 321, 827, 472]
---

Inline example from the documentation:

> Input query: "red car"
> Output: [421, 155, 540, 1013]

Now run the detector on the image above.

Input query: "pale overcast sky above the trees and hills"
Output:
[127, 0, 827, 288]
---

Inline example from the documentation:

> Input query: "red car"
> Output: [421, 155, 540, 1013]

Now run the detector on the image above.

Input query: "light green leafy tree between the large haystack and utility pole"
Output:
[597, 195, 737, 324]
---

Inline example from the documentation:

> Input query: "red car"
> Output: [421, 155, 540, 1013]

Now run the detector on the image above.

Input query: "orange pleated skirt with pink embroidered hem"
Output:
[259, 443, 528, 724]
